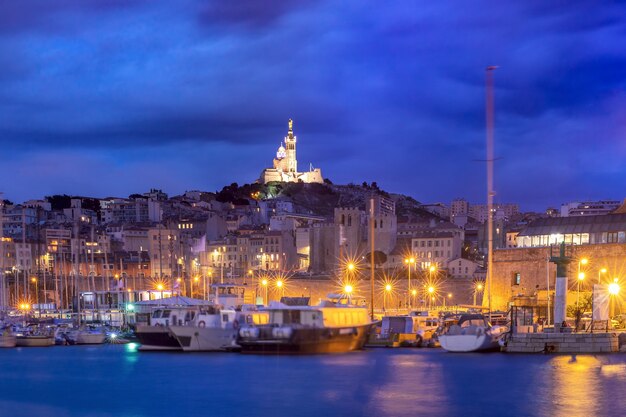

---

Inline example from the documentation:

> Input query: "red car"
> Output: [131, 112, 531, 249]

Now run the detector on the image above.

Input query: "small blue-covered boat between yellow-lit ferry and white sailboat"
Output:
[366, 311, 439, 347]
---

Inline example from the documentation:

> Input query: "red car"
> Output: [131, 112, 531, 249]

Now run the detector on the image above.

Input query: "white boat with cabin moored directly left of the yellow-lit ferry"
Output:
[169, 306, 268, 352]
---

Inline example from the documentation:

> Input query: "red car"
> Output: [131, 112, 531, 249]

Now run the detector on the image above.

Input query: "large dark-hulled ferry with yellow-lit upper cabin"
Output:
[237, 301, 373, 354]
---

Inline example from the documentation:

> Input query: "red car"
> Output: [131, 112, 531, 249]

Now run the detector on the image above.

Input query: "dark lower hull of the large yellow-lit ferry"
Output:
[237, 324, 372, 354]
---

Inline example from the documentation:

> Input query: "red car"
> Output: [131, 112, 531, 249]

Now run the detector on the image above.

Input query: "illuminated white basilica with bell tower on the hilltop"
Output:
[259, 119, 324, 184]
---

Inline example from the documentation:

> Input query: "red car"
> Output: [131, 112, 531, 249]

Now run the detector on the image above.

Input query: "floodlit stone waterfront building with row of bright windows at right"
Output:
[492, 214, 626, 309]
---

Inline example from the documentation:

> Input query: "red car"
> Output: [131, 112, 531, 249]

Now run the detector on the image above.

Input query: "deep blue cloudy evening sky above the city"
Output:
[0, 0, 626, 210]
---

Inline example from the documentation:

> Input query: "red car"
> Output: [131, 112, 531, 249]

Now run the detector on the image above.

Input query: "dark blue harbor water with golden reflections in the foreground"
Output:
[0, 345, 626, 417]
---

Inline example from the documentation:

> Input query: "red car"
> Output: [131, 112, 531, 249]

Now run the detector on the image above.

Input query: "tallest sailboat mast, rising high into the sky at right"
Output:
[485, 66, 497, 322]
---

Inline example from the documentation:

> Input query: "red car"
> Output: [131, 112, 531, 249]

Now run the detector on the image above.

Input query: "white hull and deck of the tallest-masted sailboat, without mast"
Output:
[438, 314, 508, 352]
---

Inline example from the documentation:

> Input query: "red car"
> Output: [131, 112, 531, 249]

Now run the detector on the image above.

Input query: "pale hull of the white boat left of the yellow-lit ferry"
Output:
[169, 326, 238, 352]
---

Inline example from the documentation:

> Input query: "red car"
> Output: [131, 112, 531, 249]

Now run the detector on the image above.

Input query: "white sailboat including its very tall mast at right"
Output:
[439, 66, 508, 352]
